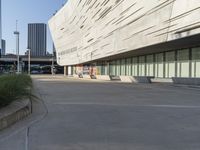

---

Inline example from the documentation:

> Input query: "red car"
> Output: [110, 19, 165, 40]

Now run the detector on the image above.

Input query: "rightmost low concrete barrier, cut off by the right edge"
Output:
[172, 77, 200, 85]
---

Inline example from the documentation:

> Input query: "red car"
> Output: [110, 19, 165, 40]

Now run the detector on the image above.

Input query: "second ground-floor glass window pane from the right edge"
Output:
[177, 49, 190, 77]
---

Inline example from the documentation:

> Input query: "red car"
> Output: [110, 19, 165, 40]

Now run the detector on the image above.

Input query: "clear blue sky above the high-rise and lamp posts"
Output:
[2, 0, 66, 54]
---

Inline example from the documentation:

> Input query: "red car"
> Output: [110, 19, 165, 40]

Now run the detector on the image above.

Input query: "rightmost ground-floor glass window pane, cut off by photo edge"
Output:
[192, 47, 200, 78]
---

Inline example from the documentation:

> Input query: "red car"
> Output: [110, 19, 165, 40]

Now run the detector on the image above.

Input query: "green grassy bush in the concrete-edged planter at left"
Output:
[0, 74, 32, 107]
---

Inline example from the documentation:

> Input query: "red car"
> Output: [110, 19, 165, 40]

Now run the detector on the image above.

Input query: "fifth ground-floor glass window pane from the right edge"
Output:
[146, 55, 154, 76]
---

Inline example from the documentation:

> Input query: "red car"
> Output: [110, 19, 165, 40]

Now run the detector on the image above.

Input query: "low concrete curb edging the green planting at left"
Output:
[0, 99, 31, 130]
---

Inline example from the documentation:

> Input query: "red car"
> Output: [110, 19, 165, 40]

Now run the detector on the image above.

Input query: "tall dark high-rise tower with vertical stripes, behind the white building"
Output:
[28, 23, 47, 56]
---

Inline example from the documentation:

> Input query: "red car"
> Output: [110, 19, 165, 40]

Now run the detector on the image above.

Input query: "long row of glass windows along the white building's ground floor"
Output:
[75, 47, 200, 78]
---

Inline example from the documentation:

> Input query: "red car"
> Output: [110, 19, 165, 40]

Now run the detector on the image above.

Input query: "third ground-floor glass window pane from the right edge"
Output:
[165, 51, 176, 78]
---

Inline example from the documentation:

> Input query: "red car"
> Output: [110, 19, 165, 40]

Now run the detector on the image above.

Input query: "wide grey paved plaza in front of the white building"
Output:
[0, 76, 200, 150]
